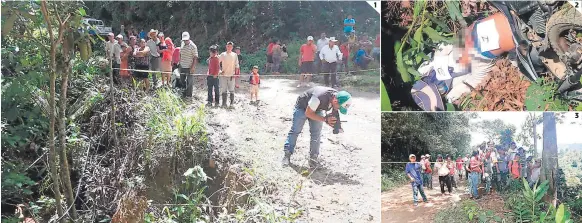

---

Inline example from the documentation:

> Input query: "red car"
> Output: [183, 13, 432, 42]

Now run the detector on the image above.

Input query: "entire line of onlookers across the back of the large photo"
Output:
[105, 15, 380, 107]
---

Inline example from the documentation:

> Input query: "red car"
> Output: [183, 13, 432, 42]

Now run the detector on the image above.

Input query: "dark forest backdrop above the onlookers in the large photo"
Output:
[85, 1, 380, 52]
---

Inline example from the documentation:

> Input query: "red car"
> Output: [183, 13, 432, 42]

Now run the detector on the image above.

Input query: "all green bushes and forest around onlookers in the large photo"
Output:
[1, 1, 379, 223]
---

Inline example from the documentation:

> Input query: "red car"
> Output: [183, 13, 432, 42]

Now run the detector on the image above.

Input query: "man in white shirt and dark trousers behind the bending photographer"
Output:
[319, 37, 343, 88]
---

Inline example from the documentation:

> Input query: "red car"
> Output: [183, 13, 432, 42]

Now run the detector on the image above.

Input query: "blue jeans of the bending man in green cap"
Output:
[284, 108, 323, 156]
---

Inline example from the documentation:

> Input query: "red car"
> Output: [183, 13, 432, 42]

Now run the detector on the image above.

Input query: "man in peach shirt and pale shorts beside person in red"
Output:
[218, 42, 240, 108]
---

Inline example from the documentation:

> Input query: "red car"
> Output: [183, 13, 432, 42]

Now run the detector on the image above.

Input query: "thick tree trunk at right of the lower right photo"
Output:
[540, 112, 558, 207]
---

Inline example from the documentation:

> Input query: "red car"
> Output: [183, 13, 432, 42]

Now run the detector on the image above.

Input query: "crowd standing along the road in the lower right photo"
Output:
[405, 141, 541, 206]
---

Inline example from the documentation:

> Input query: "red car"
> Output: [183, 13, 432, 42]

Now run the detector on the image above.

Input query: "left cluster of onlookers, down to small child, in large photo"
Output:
[105, 27, 260, 107]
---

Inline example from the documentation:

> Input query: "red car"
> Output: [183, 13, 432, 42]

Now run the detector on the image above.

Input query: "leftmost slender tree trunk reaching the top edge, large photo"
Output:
[41, 1, 65, 223]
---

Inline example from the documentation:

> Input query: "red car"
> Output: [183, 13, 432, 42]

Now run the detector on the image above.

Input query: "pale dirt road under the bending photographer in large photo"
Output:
[182, 73, 380, 222]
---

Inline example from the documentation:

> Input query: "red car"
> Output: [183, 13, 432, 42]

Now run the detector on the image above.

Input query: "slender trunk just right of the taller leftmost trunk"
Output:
[59, 29, 77, 221]
